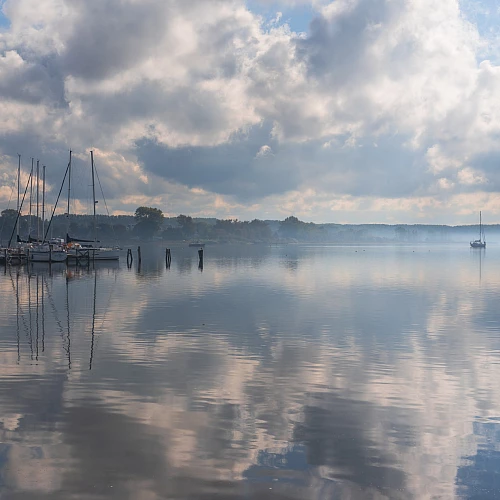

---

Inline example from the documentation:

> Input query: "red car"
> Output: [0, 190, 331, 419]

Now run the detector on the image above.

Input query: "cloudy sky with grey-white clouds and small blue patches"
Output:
[0, 0, 500, 224]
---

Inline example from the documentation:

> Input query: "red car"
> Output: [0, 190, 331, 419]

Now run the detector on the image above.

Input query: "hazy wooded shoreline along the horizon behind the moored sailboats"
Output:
[0, 206, 492, 245]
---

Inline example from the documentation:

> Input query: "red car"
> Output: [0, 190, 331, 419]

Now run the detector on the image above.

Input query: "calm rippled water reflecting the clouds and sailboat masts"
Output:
[0, 246, 500, 500]
